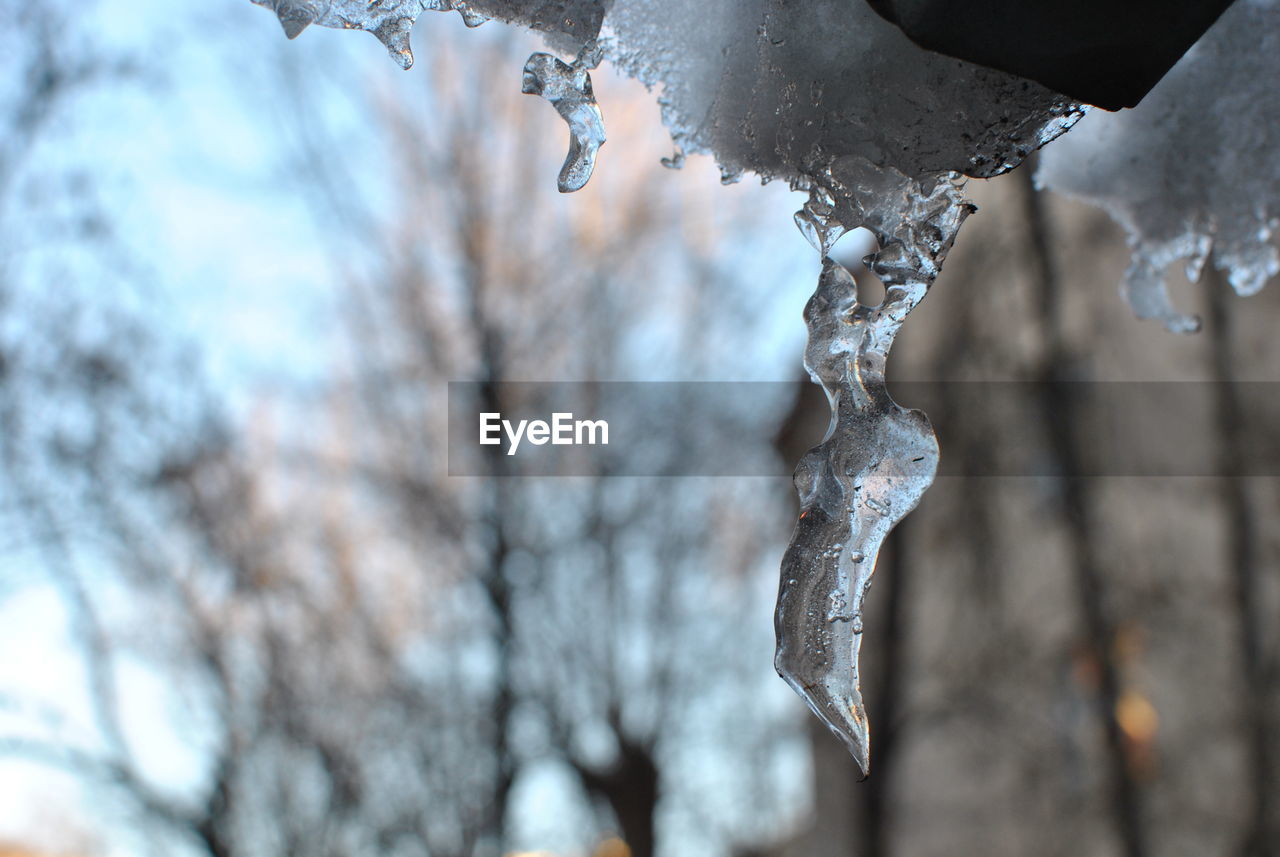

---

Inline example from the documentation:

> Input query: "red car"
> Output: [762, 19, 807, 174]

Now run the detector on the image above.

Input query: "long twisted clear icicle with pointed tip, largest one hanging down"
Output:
[774, 175, 973, 773]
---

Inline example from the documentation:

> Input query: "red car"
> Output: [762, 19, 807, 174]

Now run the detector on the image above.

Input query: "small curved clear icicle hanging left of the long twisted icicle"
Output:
[520, 47, 605, 193]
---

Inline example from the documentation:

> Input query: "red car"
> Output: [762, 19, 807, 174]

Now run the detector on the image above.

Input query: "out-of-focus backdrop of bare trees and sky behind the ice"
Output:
[0, 0, 1280, 857]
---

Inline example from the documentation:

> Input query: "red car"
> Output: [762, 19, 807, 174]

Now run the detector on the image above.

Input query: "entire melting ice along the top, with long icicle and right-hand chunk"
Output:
[253, 0, 1280, 769]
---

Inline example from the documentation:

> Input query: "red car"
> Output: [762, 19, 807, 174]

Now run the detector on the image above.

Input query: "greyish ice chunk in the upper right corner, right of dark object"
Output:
[1038, 0, 1280, 331]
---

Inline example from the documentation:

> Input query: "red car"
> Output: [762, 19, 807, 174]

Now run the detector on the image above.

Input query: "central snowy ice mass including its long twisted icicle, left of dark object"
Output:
[253, 0, 1082, 770]
